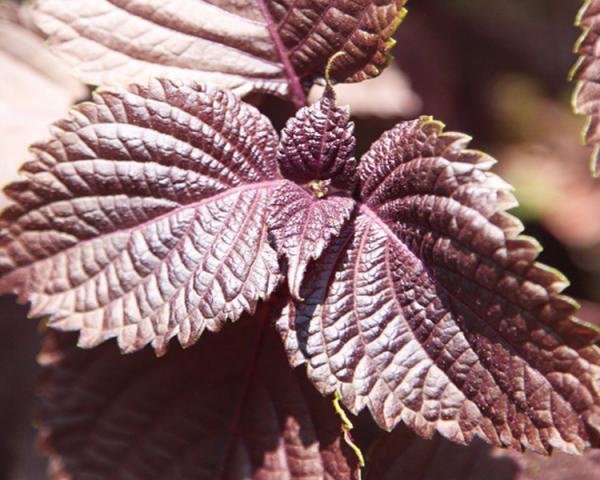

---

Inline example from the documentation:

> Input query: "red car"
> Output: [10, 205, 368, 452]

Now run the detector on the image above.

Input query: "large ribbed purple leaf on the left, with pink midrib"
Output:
[0, 80, 280, 352]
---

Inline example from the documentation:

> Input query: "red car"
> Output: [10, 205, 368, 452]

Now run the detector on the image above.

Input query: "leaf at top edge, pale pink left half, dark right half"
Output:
[36, 0, 406, 106]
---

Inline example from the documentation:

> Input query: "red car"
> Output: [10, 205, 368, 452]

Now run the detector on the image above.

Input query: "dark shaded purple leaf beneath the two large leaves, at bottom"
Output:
[40, 307, 358, 480]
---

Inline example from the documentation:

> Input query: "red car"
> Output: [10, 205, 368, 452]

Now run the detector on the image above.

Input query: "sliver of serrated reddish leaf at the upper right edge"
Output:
[571, 0, 600, 172]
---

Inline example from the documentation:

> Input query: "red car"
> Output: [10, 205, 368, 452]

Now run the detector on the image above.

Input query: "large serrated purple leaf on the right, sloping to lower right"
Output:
[277, 119, 600, 453]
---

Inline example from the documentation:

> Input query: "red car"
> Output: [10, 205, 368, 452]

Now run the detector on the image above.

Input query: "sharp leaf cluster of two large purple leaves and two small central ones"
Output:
[0, 75, 600, 458]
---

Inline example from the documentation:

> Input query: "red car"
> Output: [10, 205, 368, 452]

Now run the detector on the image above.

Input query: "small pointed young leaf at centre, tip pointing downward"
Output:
[267, 182, 355, 298]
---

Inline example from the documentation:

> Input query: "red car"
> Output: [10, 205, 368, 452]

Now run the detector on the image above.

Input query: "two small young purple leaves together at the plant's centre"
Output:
[267, 88, 356, 298]
